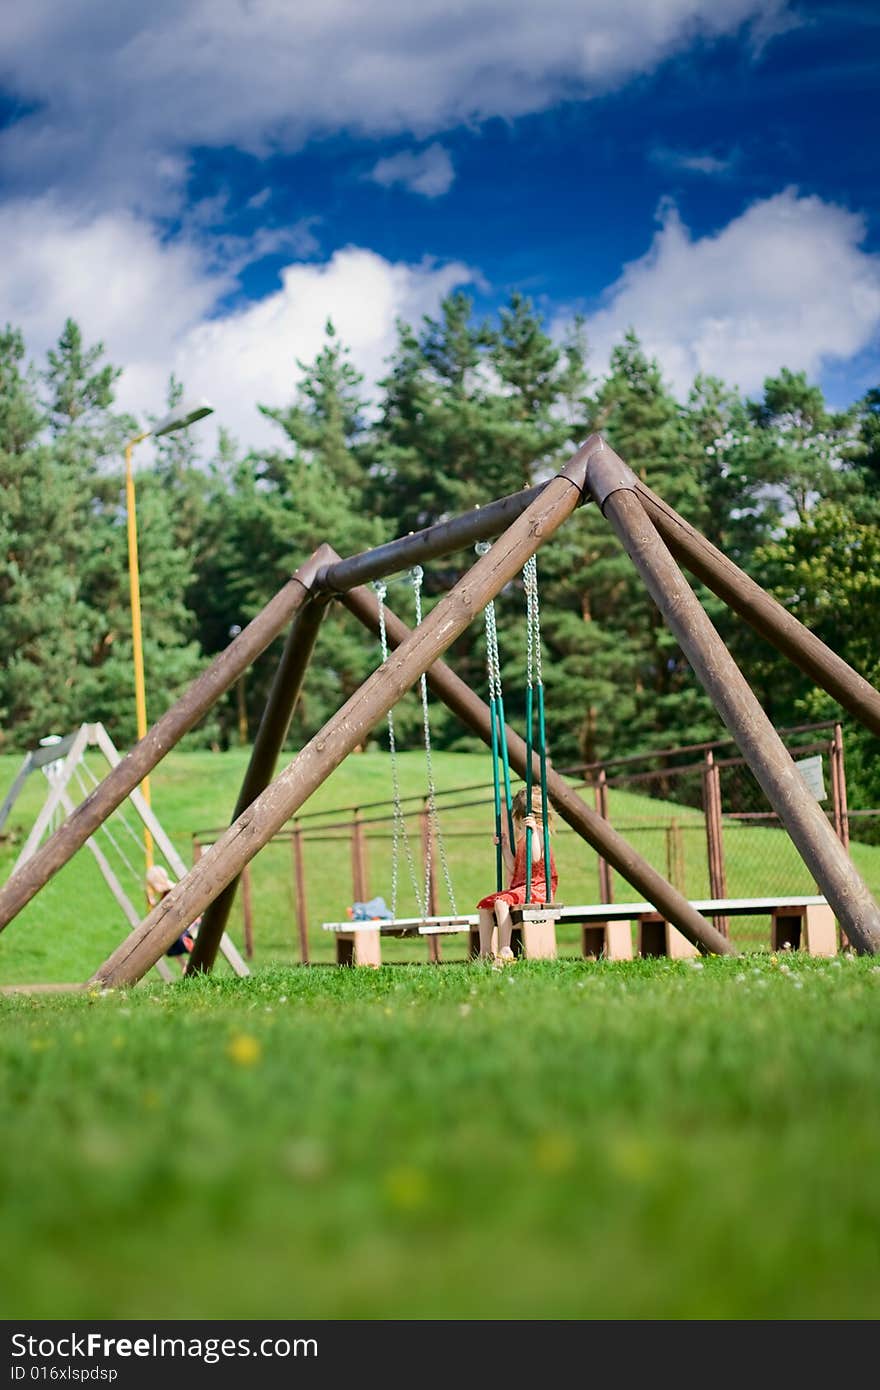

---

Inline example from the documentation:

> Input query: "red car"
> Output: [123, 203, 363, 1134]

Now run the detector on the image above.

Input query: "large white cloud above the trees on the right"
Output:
[575, 189, 880, 395]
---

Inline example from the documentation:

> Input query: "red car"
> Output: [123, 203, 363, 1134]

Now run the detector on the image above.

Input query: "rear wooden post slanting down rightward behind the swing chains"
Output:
[342, 588, 733, 955]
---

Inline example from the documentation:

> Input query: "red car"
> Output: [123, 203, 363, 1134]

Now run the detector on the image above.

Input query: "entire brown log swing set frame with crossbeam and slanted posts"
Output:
[0, 435, 880, 991]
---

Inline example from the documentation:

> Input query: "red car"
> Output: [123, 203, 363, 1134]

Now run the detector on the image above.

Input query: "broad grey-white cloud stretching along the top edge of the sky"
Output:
[0, 0, 791, 209]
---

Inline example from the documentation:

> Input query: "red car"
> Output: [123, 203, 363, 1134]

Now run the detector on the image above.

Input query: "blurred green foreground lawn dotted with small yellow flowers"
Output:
[0, 955, 880, 1319]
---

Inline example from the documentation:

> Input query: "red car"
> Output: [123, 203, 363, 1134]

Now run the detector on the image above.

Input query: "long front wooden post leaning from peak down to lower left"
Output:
[93, 436, 595, 986]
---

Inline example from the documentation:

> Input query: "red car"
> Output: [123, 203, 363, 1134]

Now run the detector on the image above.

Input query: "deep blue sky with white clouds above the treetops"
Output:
[0, 0, 880, 445]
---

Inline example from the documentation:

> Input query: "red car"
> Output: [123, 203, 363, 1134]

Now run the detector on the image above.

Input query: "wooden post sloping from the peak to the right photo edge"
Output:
[631, 480, 880, 734]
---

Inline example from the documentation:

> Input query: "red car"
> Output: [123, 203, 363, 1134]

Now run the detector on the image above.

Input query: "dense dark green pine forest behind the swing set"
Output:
[0, 295, 880, 806]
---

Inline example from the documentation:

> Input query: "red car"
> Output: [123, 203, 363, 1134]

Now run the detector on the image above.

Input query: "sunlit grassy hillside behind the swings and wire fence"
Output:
[0, 749, 880, 984]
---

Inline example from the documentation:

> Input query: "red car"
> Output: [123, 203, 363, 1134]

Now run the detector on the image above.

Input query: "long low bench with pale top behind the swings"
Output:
[324, 897, 837, 966]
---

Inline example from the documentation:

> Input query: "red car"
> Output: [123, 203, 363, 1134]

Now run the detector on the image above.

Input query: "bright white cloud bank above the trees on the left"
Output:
[0, 199, 473, 446]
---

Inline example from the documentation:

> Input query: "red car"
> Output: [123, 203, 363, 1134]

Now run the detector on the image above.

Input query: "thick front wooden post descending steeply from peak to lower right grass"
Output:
[587, 446, 880, 955]
